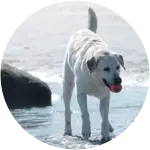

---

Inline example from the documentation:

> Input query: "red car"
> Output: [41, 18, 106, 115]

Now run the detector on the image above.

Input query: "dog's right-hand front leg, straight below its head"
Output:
[99, 92, 111, 141]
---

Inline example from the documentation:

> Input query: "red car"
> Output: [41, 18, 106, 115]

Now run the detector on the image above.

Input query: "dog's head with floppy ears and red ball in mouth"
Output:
[86, 52, 125, 93]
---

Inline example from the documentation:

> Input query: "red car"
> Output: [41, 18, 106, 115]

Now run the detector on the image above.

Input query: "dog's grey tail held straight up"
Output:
[88, 7, 97, 33]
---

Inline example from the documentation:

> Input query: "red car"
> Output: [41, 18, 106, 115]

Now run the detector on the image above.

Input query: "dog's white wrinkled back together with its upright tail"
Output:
[66, 8, 107, 70]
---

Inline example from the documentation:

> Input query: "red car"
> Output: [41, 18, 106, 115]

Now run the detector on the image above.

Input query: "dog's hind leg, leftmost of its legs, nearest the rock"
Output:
[63, 56, 74, 135]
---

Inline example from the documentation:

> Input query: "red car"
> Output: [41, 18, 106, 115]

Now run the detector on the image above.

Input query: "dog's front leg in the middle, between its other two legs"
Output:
[77, 90, 91, 140]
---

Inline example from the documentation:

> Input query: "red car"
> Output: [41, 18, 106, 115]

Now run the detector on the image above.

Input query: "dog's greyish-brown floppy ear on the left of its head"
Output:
[86, 56, 98, 74]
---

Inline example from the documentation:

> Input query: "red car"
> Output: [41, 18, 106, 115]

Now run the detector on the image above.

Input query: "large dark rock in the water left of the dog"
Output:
[0, 62, 52, 111]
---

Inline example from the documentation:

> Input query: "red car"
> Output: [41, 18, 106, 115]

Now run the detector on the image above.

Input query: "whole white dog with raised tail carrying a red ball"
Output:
[63, 8, 125, 141]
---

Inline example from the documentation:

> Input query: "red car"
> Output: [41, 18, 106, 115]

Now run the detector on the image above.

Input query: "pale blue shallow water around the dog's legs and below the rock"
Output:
[9, 77, 150, 149]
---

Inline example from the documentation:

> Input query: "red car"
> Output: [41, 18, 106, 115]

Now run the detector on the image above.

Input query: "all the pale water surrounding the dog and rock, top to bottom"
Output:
[0, 0, 150, 150]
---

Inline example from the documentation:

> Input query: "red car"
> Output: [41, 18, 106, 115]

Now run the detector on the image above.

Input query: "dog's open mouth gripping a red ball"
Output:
[103, 79, 122, 93]
